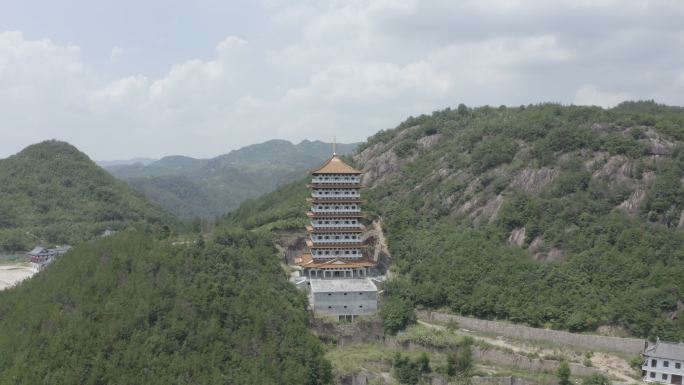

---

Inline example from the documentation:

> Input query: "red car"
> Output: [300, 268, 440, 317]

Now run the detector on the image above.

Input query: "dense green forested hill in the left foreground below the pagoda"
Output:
[0, 226, 331, 385]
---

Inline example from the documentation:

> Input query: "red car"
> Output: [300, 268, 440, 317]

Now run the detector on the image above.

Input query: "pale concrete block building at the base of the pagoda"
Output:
[309, 278, 378, 321]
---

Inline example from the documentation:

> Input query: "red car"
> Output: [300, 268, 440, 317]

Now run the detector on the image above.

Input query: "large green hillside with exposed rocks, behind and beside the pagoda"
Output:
[226, 102, 684, 340]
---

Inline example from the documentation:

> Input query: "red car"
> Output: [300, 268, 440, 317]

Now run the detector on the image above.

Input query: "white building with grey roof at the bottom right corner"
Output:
[641, 339, 684, 385]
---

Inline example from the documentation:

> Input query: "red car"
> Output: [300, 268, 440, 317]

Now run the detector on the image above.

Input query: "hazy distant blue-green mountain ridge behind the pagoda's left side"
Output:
[107, 140, 356, 218]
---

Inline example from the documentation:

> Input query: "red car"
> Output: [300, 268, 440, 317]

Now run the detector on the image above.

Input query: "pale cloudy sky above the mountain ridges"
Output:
[0, 0, 684, 160]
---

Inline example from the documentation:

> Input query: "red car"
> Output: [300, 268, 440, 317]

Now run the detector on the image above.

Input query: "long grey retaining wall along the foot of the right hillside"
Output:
[418, 311, 645, 354]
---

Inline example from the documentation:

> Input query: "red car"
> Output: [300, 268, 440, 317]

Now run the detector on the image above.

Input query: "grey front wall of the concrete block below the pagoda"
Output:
[311, 291, 378, 316]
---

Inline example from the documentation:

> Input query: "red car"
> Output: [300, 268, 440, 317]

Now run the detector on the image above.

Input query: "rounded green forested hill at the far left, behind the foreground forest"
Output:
[0, 141, 174, 251]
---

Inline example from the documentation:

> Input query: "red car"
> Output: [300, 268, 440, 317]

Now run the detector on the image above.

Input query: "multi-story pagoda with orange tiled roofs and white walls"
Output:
[295, 148, 376, 279]
